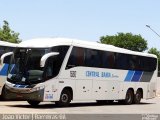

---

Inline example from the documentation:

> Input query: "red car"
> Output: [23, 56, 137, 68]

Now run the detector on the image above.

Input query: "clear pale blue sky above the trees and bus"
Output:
[0, 0, 160, 50]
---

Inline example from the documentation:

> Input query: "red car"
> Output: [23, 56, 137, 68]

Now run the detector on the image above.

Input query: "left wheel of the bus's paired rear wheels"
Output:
[124, 89, 134, 105]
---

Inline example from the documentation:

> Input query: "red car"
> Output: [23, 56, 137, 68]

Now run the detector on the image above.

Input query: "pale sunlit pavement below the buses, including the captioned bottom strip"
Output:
[0, 97, 160, 120]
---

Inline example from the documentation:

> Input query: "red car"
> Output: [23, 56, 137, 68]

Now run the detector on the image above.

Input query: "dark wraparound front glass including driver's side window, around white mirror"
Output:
[7, 46, 69, 84]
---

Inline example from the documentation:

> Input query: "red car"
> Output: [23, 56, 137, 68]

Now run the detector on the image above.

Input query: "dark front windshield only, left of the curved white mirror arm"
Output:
[8, 48, 50, 84]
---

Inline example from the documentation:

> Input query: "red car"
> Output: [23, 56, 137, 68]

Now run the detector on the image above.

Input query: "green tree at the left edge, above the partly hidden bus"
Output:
[0, 20, 21, 43]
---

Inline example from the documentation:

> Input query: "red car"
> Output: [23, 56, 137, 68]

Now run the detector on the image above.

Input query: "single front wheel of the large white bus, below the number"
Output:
[55, 89, 72, 107]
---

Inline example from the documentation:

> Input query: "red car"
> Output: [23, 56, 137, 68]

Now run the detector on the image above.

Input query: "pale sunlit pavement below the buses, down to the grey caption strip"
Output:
[0, 97, 160, 114]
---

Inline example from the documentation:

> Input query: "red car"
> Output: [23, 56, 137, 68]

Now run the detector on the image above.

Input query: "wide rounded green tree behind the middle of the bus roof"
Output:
[100, 33, 147, 52]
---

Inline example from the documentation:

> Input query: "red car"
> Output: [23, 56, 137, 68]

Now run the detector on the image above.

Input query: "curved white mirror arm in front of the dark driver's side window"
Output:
[40, 52, 59, 67]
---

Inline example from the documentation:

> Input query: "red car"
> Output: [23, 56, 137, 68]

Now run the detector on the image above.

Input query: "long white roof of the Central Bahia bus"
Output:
[19, 38, 157, 58]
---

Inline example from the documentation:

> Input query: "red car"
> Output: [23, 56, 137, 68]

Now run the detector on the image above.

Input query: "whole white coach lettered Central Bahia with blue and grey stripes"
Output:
[1, 38, 157, 106]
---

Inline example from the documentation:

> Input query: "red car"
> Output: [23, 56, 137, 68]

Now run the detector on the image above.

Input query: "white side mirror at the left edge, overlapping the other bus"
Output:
[1, 52, 13, 64]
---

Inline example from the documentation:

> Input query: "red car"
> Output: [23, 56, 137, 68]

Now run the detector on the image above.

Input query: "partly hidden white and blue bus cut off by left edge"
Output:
[0, 41, 16, 100]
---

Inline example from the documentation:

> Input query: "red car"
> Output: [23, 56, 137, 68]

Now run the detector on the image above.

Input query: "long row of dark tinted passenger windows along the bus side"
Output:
[67, 47, 157, 71]
